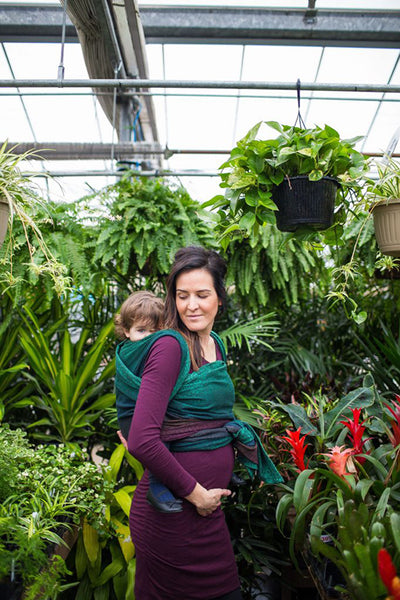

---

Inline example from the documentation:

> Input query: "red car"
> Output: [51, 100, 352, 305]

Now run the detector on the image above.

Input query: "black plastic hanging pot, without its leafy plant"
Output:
[272, 175, 339, 231]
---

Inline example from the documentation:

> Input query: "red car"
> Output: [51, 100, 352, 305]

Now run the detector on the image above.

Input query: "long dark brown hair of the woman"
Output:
[164, 246, 226, 370]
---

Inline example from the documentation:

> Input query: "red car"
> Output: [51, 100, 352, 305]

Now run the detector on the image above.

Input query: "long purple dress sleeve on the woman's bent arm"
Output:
[128, 336, 196, 497]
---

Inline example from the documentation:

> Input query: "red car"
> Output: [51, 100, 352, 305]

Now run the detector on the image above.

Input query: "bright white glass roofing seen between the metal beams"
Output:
[0, 0, 400, 200]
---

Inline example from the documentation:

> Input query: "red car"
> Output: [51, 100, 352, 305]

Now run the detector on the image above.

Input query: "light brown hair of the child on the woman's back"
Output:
[114, 290, 164, 340]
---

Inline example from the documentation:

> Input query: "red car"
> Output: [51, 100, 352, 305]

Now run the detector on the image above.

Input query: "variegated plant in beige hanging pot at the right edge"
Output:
[367, 158, 400, 256]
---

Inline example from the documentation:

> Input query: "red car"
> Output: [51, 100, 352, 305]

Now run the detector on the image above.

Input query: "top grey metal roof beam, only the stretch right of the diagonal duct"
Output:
[141, 7, 400, 48]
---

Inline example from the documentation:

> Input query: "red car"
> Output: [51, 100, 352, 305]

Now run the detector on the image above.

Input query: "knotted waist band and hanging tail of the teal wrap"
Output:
[170, 419, 283, 483]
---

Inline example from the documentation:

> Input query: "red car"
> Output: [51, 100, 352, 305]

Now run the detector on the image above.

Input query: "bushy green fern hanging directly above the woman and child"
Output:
[71, 172, 215, 289]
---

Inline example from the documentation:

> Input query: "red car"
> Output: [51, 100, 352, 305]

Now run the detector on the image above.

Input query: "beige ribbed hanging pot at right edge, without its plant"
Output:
[372, 199, 400, 256]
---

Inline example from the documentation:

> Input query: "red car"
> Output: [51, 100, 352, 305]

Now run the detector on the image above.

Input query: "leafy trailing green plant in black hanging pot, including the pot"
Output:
[206, 121, 367, 243]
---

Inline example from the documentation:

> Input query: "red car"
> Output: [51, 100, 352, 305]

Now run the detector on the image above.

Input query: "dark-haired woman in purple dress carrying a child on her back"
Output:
[128, 247, 280, 600]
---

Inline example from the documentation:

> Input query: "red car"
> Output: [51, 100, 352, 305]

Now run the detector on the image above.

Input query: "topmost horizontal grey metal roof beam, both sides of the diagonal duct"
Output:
[0, 4, 400, 48]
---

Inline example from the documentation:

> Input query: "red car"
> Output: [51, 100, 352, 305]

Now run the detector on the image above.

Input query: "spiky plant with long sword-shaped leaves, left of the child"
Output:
[19, 306, 115, 442]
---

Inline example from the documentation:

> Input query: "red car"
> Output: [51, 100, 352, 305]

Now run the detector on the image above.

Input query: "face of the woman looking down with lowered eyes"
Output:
[175, 269, 221, 335]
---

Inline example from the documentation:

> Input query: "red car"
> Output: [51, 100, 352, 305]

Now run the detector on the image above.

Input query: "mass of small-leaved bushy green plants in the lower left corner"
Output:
[0, 425, 113, 585]
